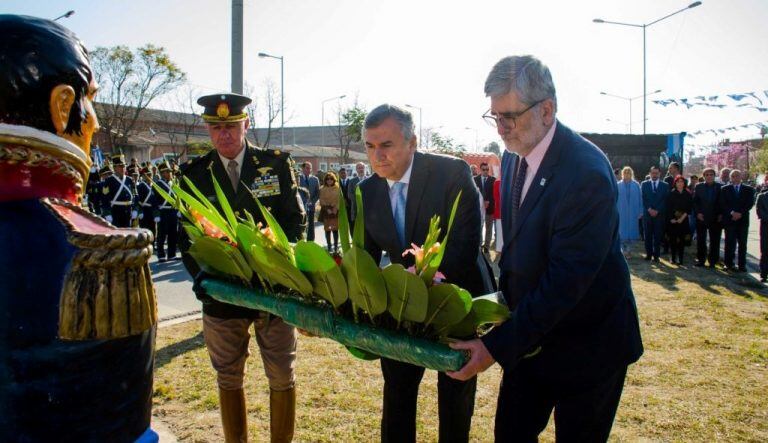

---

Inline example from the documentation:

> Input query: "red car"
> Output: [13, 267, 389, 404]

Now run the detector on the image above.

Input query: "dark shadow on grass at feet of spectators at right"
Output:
[628, 254, 768, 299]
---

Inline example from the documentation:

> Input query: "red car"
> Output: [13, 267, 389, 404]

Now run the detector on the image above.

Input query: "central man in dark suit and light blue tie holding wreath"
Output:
[359, 104, 493, 442]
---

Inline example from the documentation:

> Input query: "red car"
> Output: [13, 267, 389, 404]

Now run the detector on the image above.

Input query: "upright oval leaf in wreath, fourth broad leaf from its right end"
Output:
[341, 246, 387, 319]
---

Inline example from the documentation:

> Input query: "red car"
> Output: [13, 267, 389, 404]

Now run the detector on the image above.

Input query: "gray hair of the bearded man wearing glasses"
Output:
[485, 55, 557, 105]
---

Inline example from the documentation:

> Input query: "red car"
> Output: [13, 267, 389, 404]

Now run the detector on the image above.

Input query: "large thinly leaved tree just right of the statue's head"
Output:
[91, 44, 186, 150]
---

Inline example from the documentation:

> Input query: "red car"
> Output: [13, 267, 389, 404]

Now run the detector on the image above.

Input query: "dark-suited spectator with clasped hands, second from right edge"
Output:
[720, 169, 755, 272]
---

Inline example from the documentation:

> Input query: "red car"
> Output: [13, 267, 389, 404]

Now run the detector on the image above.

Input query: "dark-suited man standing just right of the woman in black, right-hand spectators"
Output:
[693, 168, 723, 268]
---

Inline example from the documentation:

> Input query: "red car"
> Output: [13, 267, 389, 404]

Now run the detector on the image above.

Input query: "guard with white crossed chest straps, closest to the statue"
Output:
[101, 154, 138, 228]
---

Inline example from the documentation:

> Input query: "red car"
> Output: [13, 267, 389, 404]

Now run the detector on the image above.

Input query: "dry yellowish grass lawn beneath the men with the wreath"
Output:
[154, 253, 768, 442]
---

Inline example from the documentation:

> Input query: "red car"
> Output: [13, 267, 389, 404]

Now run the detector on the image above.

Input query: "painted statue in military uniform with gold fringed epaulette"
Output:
[0, 15, 157, 442]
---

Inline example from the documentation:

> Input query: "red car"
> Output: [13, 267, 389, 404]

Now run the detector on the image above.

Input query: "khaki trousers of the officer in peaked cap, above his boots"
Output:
[203, 314, 296, 391]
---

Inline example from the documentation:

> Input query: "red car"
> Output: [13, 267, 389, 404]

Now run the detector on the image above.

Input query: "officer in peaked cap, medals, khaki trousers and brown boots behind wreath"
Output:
[181, 94, 305, 442]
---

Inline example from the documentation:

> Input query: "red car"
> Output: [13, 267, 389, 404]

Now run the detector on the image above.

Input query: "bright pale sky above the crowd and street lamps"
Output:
[0, 0, 768, 153]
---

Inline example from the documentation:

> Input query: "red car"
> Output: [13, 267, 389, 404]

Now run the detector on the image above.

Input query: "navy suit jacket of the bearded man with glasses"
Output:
[482, 122, 643, 381]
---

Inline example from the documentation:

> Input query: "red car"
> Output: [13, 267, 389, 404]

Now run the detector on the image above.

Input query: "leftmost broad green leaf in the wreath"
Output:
[189, 237, 253, 284]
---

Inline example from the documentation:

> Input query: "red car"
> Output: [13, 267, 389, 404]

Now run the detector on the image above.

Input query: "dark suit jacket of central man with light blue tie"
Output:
[359, 152, 493, 296]
